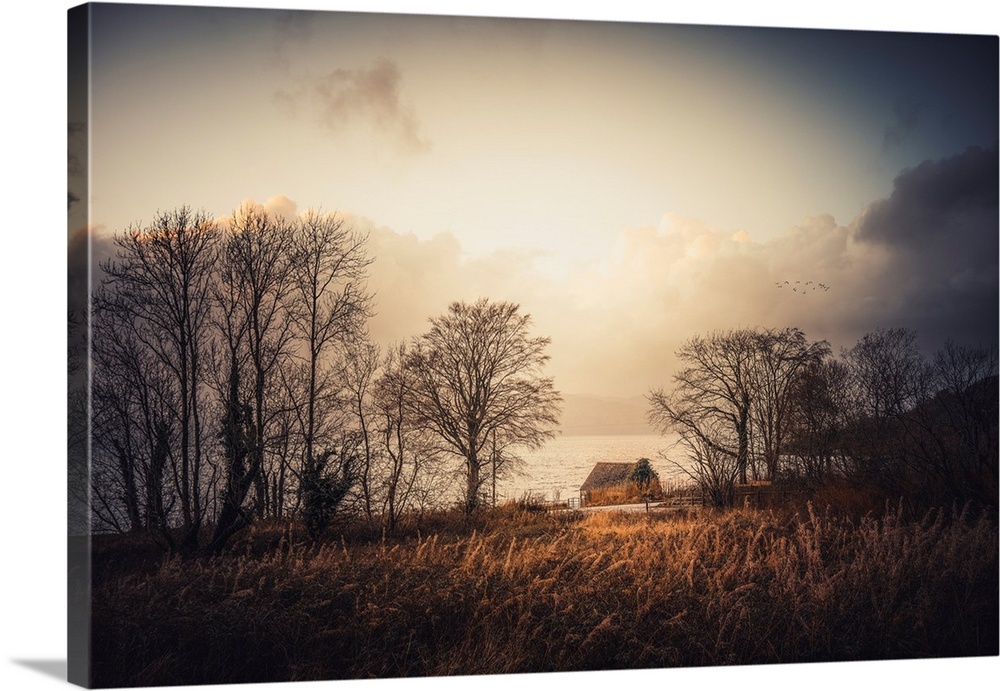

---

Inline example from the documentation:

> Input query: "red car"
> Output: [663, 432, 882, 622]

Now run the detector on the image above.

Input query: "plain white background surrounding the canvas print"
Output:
[0, 0, 1000, 690]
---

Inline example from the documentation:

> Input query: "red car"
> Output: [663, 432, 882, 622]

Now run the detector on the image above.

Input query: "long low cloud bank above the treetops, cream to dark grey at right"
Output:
[82, 142, 1000, 396]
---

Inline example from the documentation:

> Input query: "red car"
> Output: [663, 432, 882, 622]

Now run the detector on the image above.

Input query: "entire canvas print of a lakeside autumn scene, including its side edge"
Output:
[67, 3, 1000, 688]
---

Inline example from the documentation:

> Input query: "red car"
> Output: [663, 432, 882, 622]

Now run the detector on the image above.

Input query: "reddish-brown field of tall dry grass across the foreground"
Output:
[93, 506, 998, 686]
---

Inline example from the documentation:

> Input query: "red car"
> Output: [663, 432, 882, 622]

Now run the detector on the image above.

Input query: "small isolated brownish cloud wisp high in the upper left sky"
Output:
[275, 58, 430, 154]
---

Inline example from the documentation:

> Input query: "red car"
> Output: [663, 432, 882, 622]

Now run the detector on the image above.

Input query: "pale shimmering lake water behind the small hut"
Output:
[497, 434, 679, 501]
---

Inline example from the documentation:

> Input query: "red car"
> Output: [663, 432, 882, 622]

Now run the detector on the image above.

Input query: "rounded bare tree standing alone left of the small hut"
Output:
[407, 299, 561, 513]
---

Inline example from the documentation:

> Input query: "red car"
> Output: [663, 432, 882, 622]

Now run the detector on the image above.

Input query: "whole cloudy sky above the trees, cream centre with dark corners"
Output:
[69, 5, 998, 397]
